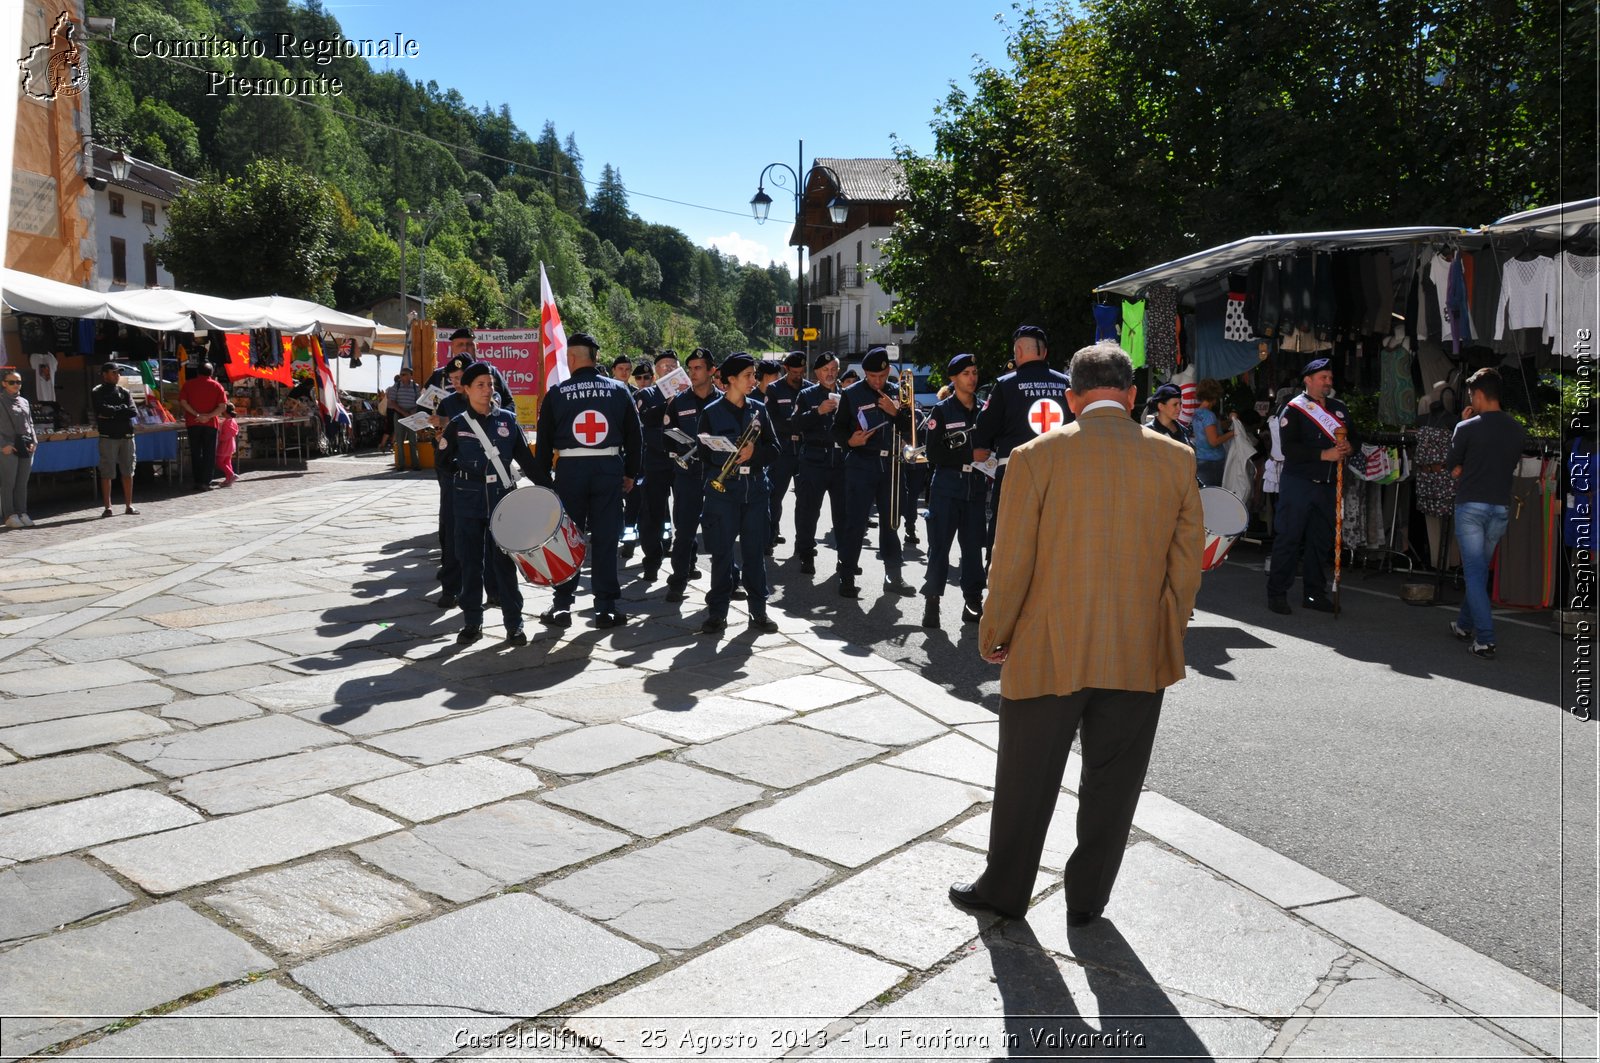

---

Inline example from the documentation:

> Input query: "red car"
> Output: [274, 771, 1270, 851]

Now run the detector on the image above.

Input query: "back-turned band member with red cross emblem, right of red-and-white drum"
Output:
[533, 333, 645, 628]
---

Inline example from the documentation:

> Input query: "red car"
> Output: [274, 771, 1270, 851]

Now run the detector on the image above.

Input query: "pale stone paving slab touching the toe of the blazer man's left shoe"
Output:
[784, 842, 1051, 970]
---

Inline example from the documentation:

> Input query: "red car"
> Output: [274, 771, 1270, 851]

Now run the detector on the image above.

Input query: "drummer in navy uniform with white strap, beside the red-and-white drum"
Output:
[438, 362, 534, 645]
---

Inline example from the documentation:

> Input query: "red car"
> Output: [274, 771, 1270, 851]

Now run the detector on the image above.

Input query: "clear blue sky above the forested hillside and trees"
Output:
[325, 0, 1011, 271]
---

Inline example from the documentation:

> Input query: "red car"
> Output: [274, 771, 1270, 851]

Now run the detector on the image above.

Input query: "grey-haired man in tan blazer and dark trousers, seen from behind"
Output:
[950, 343, 1205, 925]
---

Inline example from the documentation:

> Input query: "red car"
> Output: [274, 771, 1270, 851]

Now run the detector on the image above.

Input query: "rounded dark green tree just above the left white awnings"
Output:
[152, 158, 339, 303]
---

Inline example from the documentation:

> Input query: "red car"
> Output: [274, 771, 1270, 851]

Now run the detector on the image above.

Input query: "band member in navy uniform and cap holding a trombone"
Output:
[834, 347, 917, 597]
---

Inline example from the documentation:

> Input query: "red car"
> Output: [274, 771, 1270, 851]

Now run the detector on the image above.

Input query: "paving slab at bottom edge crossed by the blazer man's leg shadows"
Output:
[851, 941, 1274, 1060]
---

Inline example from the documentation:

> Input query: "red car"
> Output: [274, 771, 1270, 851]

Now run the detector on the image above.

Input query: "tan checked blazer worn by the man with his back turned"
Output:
[979, 407, 1205, 700]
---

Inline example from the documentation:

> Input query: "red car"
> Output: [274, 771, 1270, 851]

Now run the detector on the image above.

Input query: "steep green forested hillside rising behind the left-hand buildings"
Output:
[88, 0, 794, 351]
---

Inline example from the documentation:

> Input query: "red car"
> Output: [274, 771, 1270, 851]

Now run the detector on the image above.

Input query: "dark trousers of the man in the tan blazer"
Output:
[978, 687, 1166, 916]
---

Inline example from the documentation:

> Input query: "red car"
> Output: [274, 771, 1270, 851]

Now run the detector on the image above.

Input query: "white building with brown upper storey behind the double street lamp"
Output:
[789, 158, 917, 363]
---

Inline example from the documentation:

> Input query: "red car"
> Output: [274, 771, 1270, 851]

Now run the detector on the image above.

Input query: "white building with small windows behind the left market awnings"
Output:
[90, 144, 195, 291]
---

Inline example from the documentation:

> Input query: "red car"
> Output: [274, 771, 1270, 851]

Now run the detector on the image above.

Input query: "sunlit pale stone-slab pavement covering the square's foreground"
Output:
[0, 473, 1595, 1060]
